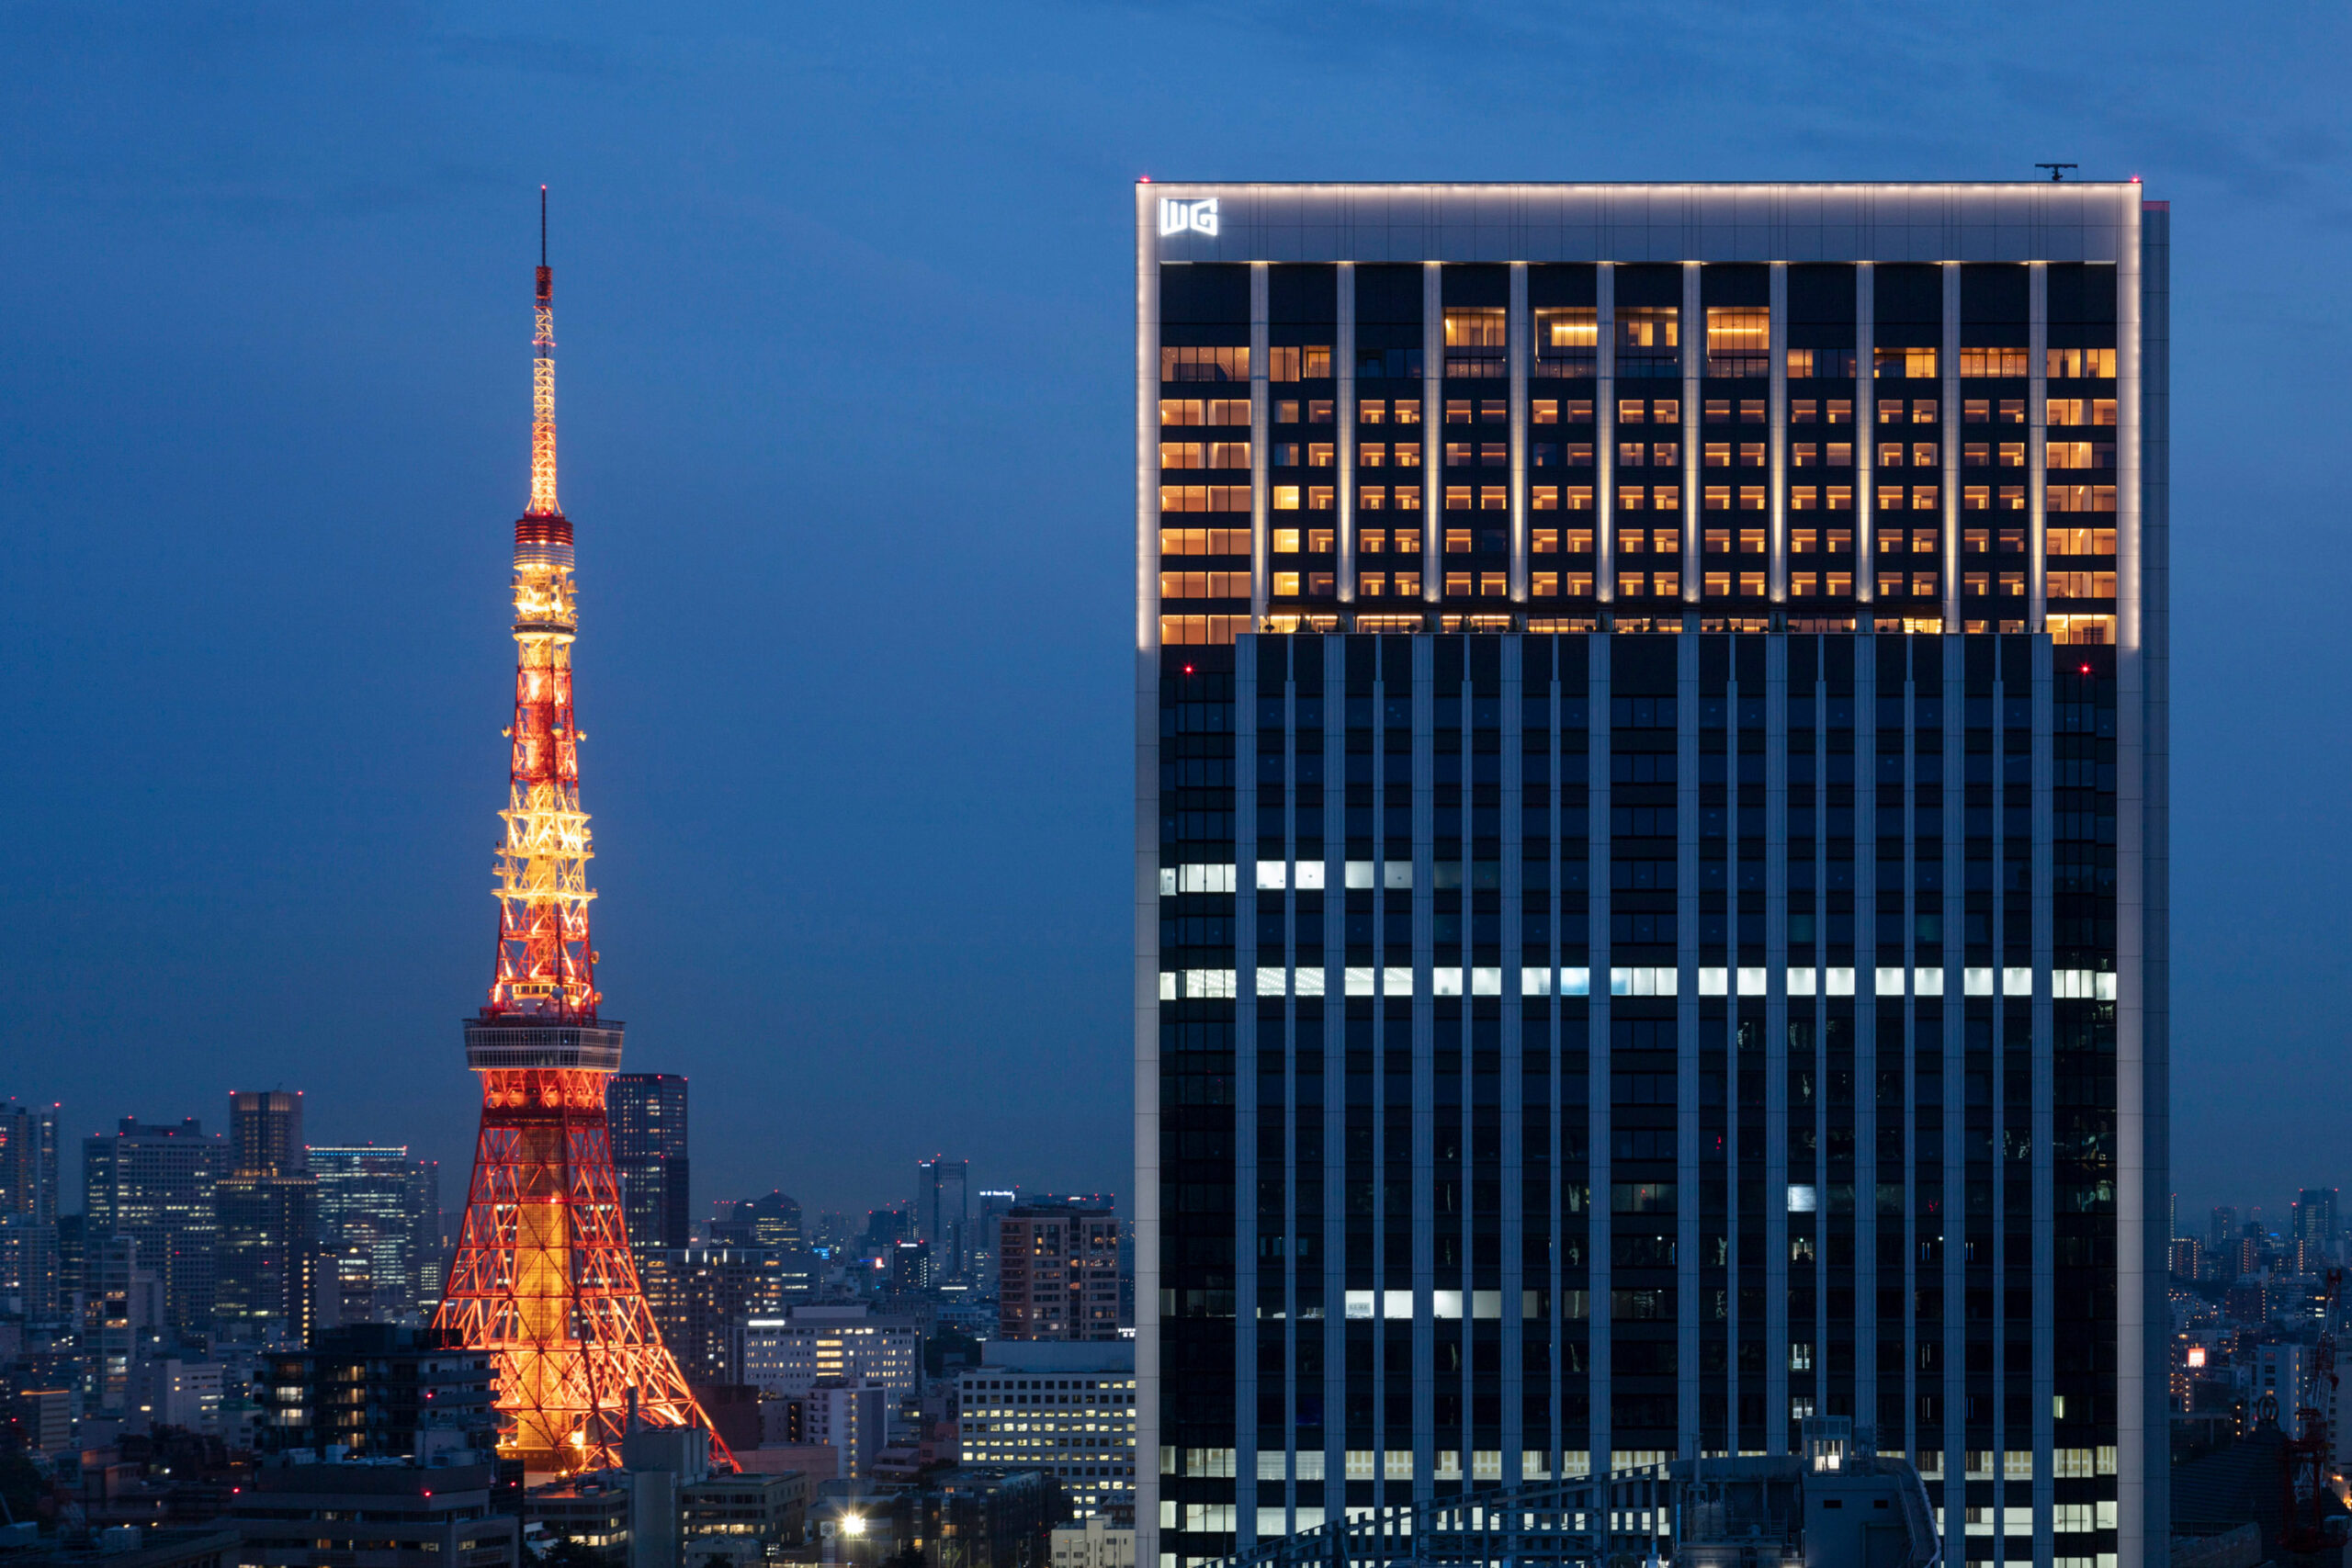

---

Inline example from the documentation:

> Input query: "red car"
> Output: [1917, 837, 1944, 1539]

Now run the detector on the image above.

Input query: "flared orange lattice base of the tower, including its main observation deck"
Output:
[435, 1016, 710, 1476]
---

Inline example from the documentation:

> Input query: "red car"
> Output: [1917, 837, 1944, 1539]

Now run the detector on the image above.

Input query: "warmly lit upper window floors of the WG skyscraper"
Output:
[1158, 264, 2120, 647]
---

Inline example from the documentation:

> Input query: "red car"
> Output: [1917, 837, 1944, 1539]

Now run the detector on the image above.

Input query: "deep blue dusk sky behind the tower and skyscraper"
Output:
[0, 12, 2345, 1250]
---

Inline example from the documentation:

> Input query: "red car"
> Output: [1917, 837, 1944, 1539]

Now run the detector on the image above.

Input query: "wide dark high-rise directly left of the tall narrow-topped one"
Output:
[83, 1117, 228, 1333]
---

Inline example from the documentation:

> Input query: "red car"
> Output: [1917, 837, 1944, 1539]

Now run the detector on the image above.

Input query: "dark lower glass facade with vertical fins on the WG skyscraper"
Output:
[1159, 635, 2117, 1556]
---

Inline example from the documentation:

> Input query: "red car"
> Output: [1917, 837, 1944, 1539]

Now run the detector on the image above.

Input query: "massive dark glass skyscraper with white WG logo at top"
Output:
[1138, 184, 2168, 1563]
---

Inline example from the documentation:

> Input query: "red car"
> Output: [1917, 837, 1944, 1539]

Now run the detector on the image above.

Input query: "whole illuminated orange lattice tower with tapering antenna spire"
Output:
[435, 186, 731, 1474]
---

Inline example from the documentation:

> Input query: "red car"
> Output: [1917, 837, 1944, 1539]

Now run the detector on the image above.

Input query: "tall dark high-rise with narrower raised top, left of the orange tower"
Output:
[214, 1089, 320, 1345]
